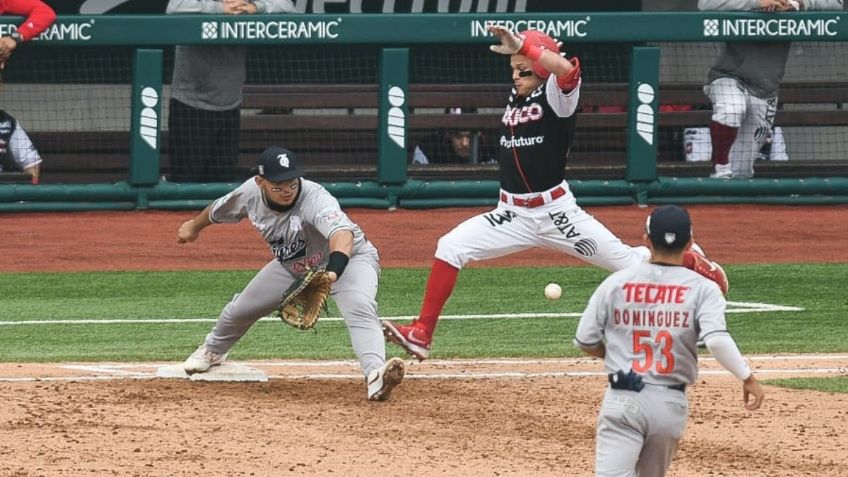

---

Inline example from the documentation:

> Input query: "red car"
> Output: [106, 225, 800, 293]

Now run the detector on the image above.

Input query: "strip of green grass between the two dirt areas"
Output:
[0, 264, 848, 389]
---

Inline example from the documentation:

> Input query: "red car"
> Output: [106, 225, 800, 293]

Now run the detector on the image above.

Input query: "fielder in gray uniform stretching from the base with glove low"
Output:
[178, 146, 404, 401]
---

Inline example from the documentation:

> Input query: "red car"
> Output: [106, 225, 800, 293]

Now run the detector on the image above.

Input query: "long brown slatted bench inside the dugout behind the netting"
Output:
[23, 82, 848, 183]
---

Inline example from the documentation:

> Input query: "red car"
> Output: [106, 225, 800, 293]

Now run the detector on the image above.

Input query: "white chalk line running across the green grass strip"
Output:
[0, 301, 804, 326]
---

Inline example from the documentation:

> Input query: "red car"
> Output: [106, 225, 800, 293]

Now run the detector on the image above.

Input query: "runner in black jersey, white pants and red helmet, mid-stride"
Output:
[383, 25, 728, 360]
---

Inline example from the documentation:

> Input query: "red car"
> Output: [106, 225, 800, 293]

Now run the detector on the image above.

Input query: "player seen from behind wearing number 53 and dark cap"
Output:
[574, 205, 763, 477]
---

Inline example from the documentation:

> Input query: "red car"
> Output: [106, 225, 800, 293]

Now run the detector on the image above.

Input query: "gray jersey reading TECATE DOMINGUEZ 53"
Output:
[575, 263, 727, 385]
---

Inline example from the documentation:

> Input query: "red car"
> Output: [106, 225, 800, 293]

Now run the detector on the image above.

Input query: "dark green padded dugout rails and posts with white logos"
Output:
[0, 12, 848, 211]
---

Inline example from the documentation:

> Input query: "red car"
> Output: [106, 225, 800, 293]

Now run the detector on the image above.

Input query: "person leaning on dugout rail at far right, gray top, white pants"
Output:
[698, 0, 843, 179]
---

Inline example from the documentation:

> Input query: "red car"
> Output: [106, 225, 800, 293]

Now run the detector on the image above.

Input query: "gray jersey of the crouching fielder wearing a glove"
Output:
[209, 177, 373, 275]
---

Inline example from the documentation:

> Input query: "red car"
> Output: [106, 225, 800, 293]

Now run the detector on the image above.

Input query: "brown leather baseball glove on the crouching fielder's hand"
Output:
[280, 267, 332, 330]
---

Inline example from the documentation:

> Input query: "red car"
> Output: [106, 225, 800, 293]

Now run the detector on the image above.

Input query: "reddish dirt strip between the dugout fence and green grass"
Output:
[0, 205, 848, 272]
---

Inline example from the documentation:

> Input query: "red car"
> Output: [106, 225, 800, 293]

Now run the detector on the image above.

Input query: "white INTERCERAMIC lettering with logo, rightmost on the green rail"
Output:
[704, 15, 841, 38]
